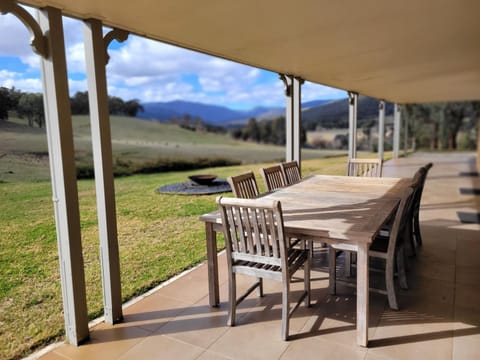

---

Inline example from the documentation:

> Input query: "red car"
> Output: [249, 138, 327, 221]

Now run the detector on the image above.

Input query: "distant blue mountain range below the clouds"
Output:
[137, 100, 331, 126]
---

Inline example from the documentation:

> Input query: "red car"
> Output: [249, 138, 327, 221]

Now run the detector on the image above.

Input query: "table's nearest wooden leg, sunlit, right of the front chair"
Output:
[357, 243, 369, 347]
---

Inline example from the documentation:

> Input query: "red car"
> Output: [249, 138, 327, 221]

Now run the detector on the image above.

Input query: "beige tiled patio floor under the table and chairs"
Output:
[34, 154, 480, 360]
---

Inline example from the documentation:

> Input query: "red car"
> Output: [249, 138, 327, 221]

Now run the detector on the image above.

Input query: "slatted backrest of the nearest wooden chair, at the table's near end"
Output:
[217, 196, 287, 268]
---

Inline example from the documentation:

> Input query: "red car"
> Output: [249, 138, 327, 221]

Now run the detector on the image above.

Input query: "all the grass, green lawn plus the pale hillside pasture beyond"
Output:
[0, 117, 386, 359]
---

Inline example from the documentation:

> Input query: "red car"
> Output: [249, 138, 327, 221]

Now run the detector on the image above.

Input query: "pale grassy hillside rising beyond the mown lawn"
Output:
[0, 115, 342, 183]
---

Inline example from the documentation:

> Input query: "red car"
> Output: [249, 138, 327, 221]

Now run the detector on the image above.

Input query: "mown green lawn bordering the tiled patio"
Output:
[0, 158, 372, 358]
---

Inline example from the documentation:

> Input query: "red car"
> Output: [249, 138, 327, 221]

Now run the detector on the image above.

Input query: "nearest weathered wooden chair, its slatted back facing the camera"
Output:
[217, 197, 310, 340]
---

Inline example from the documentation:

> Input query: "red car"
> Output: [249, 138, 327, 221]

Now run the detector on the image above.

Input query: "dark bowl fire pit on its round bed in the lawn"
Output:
[157, 174, 232, 195]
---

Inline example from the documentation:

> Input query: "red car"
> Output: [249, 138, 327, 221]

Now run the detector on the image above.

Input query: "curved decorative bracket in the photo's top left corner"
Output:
[0, 0, 48, 58]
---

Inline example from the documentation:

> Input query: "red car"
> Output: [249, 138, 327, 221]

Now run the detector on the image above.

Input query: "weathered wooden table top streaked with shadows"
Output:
[200, 175, 411, 244]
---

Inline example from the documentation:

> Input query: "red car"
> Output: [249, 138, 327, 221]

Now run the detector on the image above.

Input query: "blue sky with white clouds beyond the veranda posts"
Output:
[0, 5, 347, 110]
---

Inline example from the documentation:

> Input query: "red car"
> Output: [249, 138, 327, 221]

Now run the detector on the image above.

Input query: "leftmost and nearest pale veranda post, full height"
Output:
[38, 7, 88, 345]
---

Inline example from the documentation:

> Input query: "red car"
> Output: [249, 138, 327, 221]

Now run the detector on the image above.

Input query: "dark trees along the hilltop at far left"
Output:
[0, 87, 143, 128]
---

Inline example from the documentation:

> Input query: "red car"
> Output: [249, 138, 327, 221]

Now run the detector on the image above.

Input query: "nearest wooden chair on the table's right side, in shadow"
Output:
[329, 186, 414, 310]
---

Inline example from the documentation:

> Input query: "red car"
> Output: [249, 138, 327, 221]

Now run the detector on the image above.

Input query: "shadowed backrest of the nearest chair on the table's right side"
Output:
[387, 184, 415, 259]
